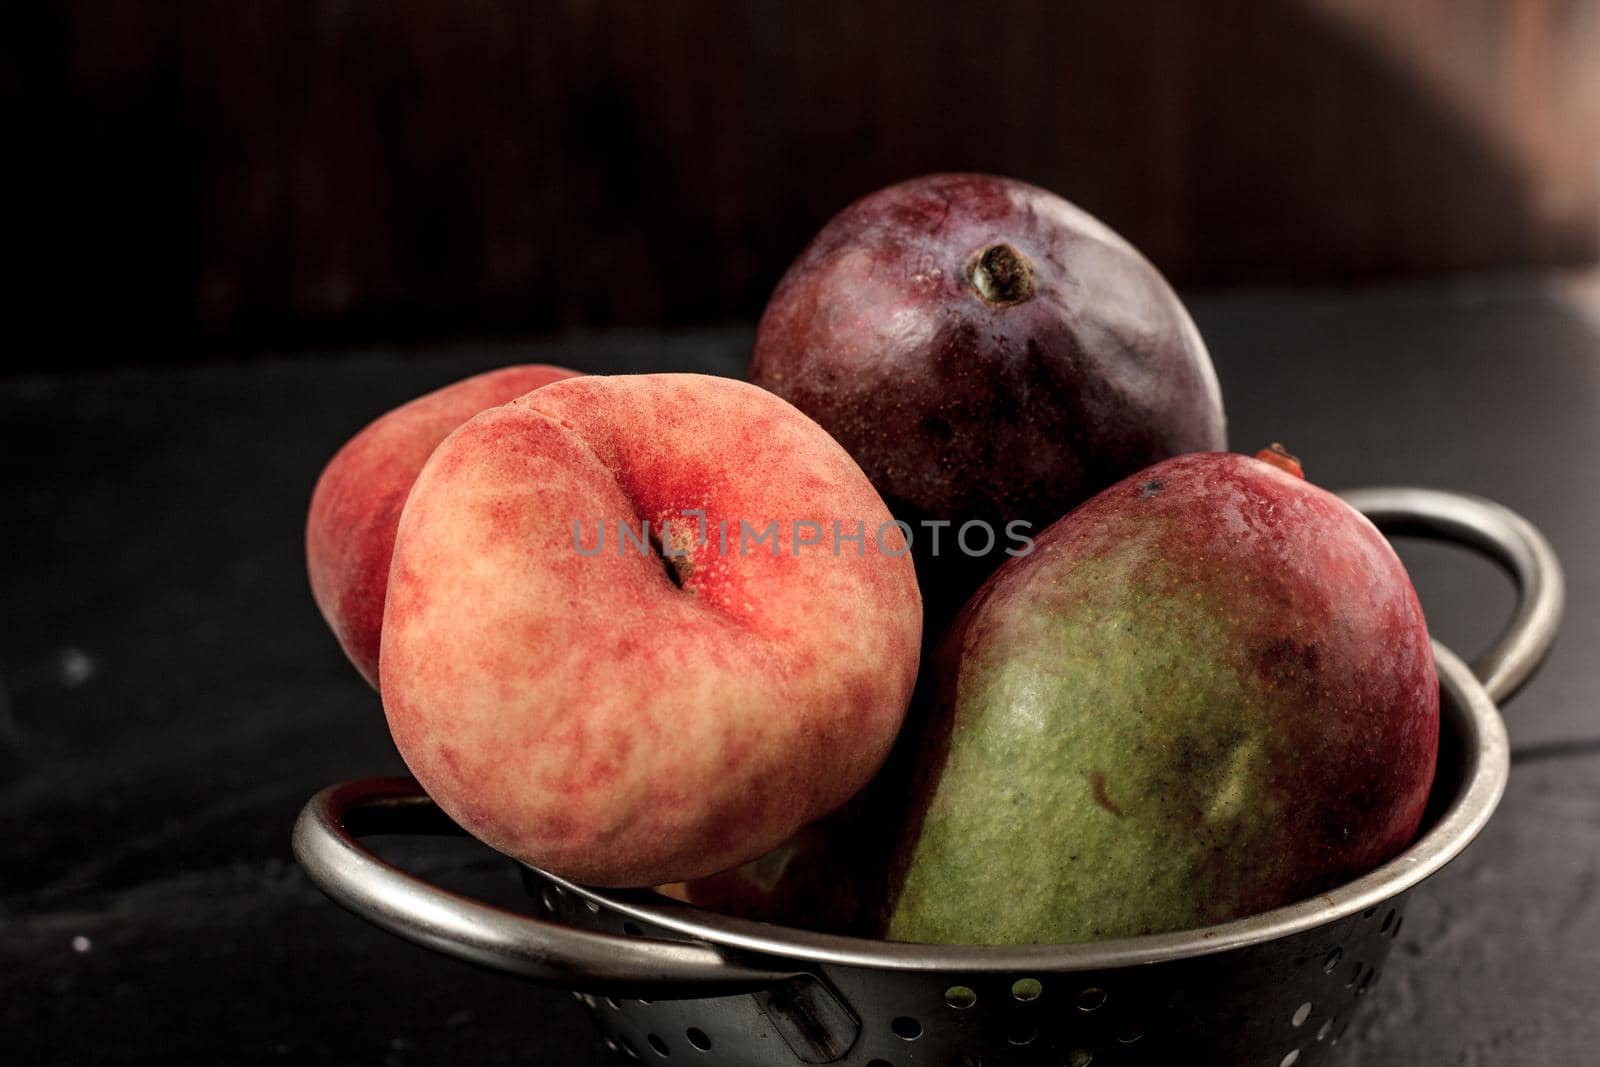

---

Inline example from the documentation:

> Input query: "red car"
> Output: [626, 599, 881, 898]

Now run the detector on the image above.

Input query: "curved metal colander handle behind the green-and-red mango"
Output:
[1339, 486, 1566, 704]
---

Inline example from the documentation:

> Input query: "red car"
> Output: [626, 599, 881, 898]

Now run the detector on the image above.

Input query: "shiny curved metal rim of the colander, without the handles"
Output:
[534, 641, 1510, 973]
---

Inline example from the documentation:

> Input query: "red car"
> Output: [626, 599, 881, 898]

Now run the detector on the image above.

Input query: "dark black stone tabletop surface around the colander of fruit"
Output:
[0, 280, 1600, 1065]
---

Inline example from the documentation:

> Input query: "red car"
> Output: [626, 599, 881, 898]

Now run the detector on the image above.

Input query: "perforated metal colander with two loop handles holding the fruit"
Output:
[294, 488, 1563, 1067]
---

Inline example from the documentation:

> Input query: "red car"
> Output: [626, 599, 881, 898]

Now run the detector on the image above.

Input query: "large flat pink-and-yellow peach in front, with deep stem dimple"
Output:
[381, 374, 922, 886]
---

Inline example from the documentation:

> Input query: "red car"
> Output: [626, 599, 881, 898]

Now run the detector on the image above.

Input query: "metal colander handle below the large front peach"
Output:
[294, 777, 802, 1000]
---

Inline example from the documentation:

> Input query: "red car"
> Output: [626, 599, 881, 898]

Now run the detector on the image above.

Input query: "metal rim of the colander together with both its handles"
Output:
[293, 486, 1565, 997]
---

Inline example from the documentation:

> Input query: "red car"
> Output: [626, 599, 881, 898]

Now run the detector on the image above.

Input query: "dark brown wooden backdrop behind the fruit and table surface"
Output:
[0, 0, 1600, 366]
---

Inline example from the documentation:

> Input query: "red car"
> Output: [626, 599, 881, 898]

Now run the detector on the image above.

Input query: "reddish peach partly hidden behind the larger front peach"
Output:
[306, 365, 578, 686]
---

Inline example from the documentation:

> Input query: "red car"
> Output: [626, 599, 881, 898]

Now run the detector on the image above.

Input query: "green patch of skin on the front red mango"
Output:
[888, 544, 1283, 944]
